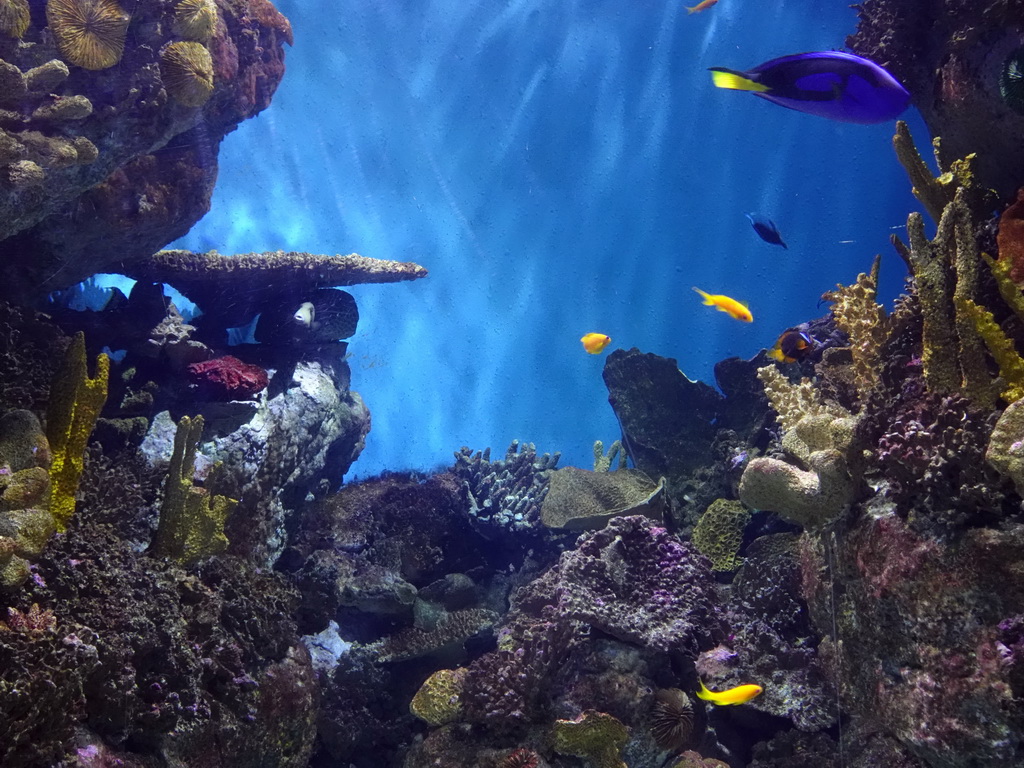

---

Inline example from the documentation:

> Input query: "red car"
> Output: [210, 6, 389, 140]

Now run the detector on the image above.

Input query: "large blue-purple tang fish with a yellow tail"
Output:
[711, 51, 910, 125]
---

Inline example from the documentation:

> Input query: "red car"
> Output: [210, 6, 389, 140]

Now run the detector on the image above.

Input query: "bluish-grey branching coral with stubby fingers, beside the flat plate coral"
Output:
[452, 440, 559, 531]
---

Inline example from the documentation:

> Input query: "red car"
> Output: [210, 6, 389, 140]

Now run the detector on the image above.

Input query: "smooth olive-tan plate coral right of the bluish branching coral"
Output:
[541, 467, 665, 530]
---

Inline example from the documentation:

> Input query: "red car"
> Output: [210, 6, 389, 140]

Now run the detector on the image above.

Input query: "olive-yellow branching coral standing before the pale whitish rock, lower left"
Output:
[153, 416, 238, 565]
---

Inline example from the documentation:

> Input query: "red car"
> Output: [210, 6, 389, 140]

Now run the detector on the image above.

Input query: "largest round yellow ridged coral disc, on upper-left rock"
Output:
[46, 0, 129, 70]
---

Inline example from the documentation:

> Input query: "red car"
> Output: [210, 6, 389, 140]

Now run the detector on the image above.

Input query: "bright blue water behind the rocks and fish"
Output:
[178, 0, 928, 476]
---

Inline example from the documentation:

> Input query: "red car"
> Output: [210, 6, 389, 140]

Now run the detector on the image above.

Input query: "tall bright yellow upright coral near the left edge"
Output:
[46, 333, 111, 532]
